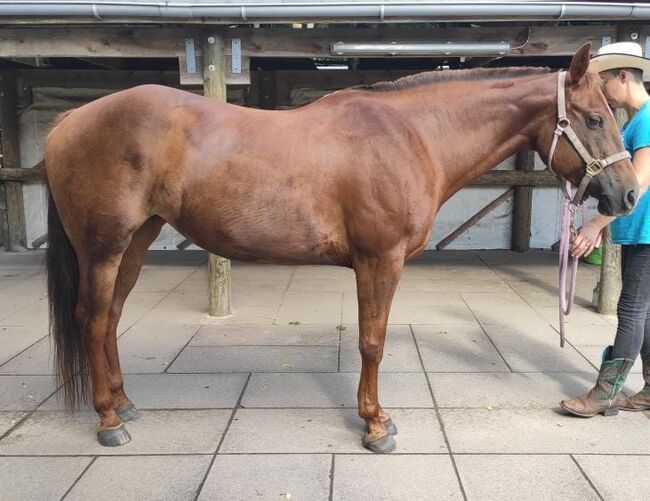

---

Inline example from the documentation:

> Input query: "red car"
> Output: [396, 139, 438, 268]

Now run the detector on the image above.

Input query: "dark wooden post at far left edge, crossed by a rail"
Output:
[0, 71, 27, 251]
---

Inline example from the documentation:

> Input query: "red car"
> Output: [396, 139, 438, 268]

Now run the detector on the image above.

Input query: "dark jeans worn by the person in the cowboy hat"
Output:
[612, 244, 650, 360]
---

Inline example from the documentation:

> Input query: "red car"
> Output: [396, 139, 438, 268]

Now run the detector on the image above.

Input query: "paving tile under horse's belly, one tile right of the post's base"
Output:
[276, 292, 343, 325]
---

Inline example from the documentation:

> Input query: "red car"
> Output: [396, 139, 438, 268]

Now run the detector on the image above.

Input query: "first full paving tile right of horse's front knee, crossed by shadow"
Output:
[413, 324, 510, 372]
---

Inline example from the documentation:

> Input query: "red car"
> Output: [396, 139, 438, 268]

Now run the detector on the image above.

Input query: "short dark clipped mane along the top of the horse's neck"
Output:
[352, 66, 552, 92]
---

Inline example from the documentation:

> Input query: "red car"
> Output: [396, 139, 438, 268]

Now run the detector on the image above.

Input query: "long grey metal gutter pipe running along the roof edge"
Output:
[0, 0, 650, 23]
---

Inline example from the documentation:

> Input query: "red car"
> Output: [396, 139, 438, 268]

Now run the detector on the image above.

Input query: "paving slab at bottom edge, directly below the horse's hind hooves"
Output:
[66, 456, 210, 501]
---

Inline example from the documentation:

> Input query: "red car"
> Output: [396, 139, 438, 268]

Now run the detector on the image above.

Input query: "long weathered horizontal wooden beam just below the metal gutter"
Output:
[0, 25, 617, 58]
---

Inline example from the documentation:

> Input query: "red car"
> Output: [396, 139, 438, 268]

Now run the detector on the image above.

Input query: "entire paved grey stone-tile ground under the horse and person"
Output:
[0, 248, 650, 501]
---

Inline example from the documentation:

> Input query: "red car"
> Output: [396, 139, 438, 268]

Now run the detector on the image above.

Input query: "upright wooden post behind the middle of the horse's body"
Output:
[203, 29, 231, 317]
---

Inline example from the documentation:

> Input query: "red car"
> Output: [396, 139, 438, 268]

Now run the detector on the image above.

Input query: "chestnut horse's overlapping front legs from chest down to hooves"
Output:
[354, 252, 404, 453]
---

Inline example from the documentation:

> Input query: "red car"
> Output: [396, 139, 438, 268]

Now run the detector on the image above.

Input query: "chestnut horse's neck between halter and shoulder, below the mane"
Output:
[402, 74, 556, 200]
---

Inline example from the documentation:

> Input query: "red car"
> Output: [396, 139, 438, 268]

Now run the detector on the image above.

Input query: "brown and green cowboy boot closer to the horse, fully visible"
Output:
[560, 346, 634, 417]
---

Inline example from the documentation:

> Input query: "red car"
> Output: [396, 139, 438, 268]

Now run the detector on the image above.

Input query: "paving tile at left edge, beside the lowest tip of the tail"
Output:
[0, 376, 56, 411]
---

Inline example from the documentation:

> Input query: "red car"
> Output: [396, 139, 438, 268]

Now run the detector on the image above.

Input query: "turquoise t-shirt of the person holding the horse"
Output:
[611, 101, 650, 245]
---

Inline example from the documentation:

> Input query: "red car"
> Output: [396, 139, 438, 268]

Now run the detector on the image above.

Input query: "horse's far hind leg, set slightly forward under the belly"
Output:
[104, 216, 165, 422]
